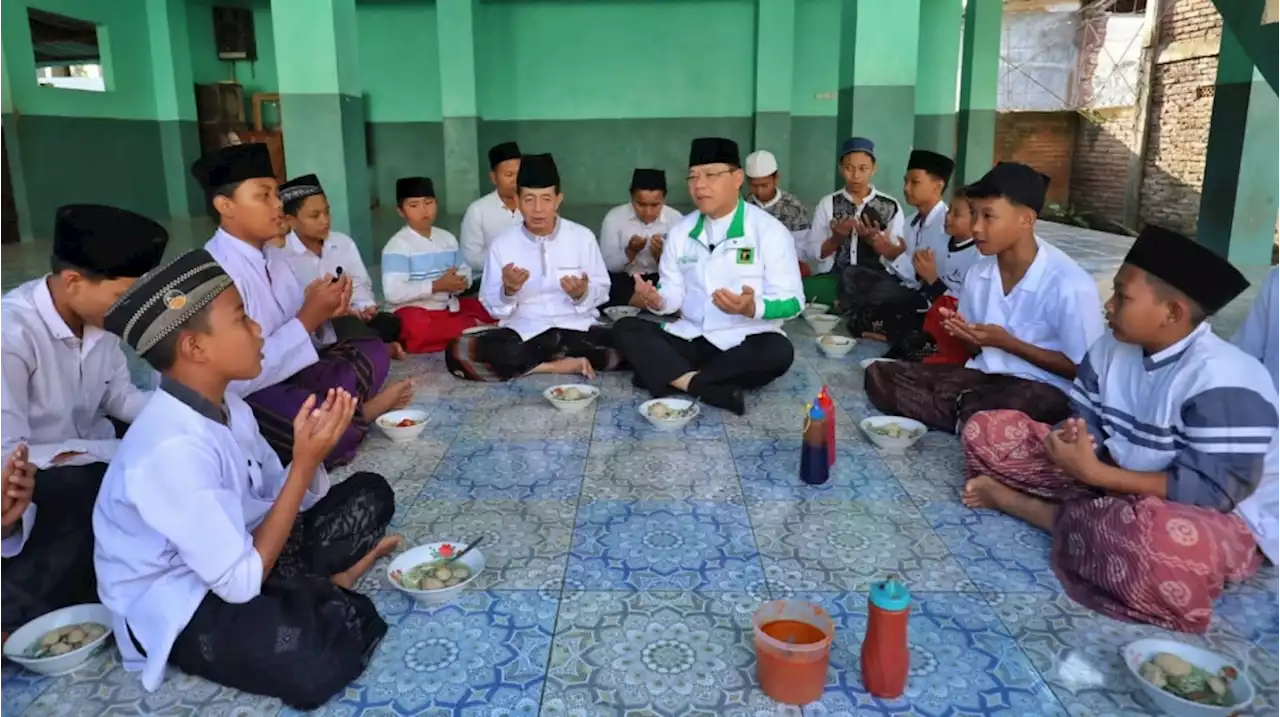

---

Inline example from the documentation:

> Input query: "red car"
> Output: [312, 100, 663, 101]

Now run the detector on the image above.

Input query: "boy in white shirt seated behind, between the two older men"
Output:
[600, 169, 682, 306]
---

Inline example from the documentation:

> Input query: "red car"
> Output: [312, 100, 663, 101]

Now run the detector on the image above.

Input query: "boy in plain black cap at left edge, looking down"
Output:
[0, 205, 169, 641]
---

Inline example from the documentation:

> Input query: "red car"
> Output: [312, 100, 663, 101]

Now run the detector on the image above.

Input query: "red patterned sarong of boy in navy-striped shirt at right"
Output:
[963, 411, 1262, 632]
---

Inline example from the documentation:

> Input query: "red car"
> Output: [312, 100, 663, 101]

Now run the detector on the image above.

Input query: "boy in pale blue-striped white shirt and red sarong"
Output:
[383, 177, 493, 353]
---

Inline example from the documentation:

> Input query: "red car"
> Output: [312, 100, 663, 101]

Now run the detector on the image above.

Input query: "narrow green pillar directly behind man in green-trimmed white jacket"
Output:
[753, 0, 796, 181]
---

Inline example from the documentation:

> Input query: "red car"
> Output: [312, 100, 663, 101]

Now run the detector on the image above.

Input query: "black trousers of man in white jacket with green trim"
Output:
[613, 318, 795, 396]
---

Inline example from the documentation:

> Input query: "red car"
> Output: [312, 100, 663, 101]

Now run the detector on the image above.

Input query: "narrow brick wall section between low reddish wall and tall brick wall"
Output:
[1071, 108, 1137, 224]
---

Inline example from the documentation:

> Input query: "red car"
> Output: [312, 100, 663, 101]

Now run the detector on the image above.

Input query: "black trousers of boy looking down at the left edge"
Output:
[0, 463, 106, 632]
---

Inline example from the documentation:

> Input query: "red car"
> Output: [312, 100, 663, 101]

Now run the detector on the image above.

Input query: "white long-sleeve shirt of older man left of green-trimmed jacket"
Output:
[480, 216, 609, 341]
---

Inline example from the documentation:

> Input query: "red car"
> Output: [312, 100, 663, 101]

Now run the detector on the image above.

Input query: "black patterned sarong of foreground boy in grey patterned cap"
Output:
[169, 472, 396, 709]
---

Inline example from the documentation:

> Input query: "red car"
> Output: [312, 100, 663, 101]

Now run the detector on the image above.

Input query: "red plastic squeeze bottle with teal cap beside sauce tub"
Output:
[863, 577, 911, 699]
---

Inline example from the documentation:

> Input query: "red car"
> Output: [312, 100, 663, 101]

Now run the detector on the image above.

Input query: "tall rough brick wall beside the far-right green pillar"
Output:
[1140, 0, 1222, 234]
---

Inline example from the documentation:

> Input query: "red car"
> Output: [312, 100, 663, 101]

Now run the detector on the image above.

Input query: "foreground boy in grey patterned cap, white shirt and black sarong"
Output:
[93, 250, 399, 709]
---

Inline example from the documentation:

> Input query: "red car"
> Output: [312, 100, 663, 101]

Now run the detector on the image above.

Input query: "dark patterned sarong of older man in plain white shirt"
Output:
[444, 326, 622, 382]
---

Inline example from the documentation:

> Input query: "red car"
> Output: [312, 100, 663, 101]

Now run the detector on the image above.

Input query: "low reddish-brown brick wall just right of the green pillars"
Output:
[996, 111, 1078, 206]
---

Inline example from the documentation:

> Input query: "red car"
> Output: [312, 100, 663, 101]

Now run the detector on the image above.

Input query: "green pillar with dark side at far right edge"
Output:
[1196, 26, 1280, 266]
